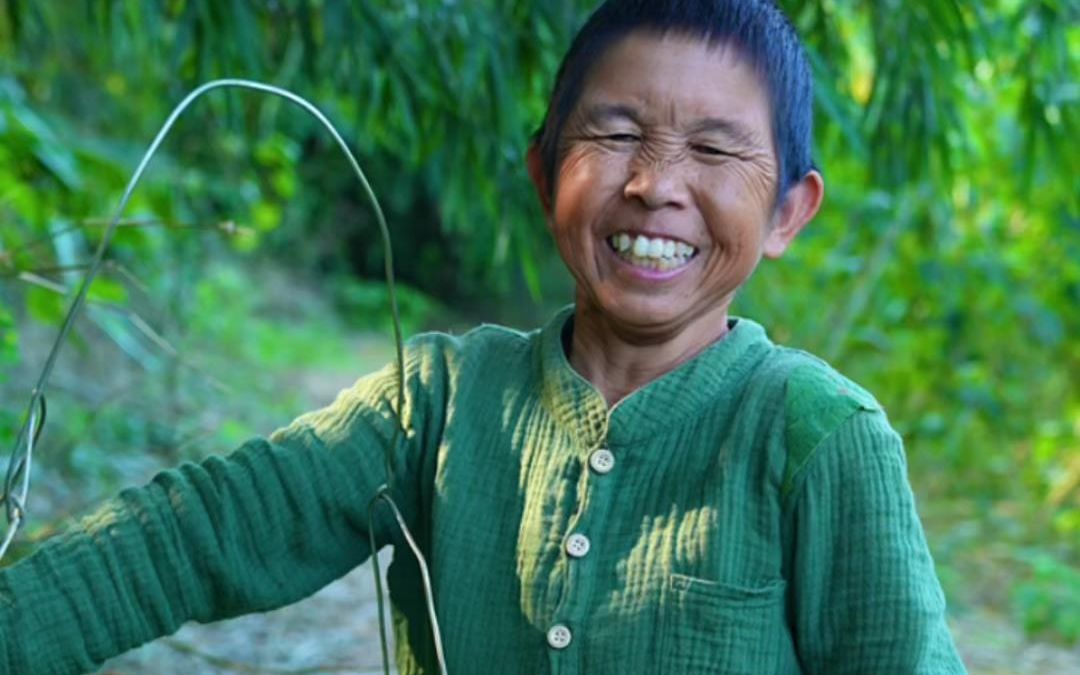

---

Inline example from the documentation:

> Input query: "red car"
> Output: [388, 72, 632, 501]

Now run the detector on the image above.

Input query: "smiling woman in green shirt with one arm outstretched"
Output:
[0, 0, 963, 675]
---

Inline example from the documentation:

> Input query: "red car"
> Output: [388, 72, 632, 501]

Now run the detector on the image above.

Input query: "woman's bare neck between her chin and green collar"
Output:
[568, 298, 728, 406]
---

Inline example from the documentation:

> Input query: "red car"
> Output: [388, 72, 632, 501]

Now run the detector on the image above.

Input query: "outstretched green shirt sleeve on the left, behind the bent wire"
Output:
[0, 349, 434, 674]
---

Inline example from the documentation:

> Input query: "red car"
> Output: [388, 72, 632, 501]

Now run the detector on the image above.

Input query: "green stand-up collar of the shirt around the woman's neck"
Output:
[540, 305, 772, 448]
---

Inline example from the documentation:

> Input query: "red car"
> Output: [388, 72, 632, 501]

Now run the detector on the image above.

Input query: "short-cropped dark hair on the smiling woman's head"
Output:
[534, 0, 814, 203]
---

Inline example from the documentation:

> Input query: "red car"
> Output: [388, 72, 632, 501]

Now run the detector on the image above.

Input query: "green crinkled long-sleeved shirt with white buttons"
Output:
[0, 310, 963, 675]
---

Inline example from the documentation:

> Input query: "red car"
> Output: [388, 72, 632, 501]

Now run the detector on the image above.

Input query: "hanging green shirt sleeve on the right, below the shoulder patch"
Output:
[789, 410, 966, 675]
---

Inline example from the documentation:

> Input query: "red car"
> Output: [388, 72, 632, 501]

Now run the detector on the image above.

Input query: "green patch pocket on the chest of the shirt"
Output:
[660, 575, 787, 675]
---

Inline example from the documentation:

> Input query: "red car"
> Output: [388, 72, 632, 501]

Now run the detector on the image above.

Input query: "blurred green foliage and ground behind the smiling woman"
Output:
[0, 0, 1080, 673]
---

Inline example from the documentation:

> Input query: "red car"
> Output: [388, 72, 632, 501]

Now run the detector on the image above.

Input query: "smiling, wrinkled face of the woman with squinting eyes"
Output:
[530, 33, 812, 337]
